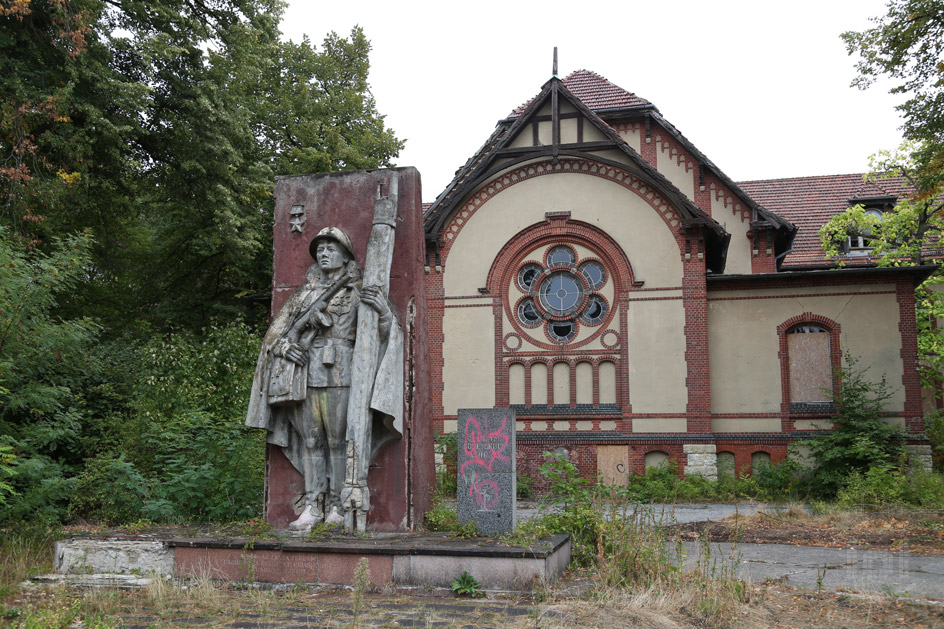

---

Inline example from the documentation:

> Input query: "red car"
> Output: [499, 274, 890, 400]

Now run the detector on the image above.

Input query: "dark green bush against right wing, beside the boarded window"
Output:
[808, 354, 905, 498]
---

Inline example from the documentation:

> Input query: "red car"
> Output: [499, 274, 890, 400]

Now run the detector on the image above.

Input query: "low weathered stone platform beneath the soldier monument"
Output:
[55, 533, 571, 591]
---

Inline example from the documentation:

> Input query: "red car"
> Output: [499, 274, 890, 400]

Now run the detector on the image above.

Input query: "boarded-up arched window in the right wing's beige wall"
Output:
[787, 325, 833, 403]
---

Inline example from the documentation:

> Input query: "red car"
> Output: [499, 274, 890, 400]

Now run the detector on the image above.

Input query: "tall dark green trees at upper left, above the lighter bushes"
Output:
[0, 0, 402, 336]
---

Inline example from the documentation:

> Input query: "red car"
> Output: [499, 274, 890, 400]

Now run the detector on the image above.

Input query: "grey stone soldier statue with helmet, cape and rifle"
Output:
[246, 189, 403, 531]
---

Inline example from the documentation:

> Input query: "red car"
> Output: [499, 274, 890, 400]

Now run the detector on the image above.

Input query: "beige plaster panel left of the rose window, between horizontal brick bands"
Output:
[442, 307, 495, 415]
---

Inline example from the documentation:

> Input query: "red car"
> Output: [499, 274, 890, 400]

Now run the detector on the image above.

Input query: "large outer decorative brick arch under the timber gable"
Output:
[440, 157, 684, 266]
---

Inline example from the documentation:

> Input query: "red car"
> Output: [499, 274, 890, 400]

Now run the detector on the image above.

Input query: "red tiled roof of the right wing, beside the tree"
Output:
[738, 174, 908, 268]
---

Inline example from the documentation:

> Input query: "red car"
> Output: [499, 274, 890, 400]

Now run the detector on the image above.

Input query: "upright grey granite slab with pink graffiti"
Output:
[456, 408, 518, 535]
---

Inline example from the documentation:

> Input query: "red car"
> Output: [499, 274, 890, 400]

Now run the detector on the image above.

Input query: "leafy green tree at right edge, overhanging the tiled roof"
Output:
[820, 0, 944, 398]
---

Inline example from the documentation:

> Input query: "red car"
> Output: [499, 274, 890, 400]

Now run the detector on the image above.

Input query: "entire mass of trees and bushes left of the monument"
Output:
[0, 0, 402, 522]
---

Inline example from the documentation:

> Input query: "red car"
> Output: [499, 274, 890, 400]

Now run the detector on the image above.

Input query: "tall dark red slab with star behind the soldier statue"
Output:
[265, 168, 436, 531]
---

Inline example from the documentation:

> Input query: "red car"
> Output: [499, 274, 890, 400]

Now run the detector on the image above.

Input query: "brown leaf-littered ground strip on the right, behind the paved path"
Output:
[671, 512, 944, 555]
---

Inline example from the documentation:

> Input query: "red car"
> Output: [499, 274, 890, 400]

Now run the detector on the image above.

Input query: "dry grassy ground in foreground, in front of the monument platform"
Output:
[0, 575, 944, 629]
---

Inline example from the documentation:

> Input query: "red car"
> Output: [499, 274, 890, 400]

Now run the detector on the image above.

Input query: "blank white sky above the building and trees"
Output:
[282, 0, 901, 201]
